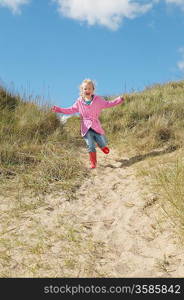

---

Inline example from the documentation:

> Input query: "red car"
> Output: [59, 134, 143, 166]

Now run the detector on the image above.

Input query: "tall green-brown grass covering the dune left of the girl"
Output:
[0, 88, 84, 197]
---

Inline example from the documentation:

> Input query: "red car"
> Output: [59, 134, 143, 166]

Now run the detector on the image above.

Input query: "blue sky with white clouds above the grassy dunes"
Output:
[0, 0, 184, 107]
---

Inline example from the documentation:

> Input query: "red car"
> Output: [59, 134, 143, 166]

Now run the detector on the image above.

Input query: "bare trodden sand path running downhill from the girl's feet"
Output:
[72, 149, 184, 277]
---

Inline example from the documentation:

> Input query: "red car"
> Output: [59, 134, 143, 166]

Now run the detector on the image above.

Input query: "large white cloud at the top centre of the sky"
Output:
[52, 0, 152, 30]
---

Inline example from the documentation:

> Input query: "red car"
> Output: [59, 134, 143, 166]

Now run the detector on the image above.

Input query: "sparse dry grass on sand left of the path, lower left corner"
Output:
[0, 191, 109, 278]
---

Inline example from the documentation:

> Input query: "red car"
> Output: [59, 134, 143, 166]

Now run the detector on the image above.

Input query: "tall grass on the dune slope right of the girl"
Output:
[101, 81, 184, 153]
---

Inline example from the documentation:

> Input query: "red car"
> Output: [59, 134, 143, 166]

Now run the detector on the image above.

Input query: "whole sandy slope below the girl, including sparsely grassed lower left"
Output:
[0, 149, 184, 277]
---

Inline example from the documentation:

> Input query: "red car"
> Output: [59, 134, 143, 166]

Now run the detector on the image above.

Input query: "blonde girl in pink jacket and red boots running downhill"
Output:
[52, 79, 124, 169]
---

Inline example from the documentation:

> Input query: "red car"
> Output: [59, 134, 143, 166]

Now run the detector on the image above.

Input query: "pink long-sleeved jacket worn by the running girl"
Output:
[54, 95, 124, 136]
